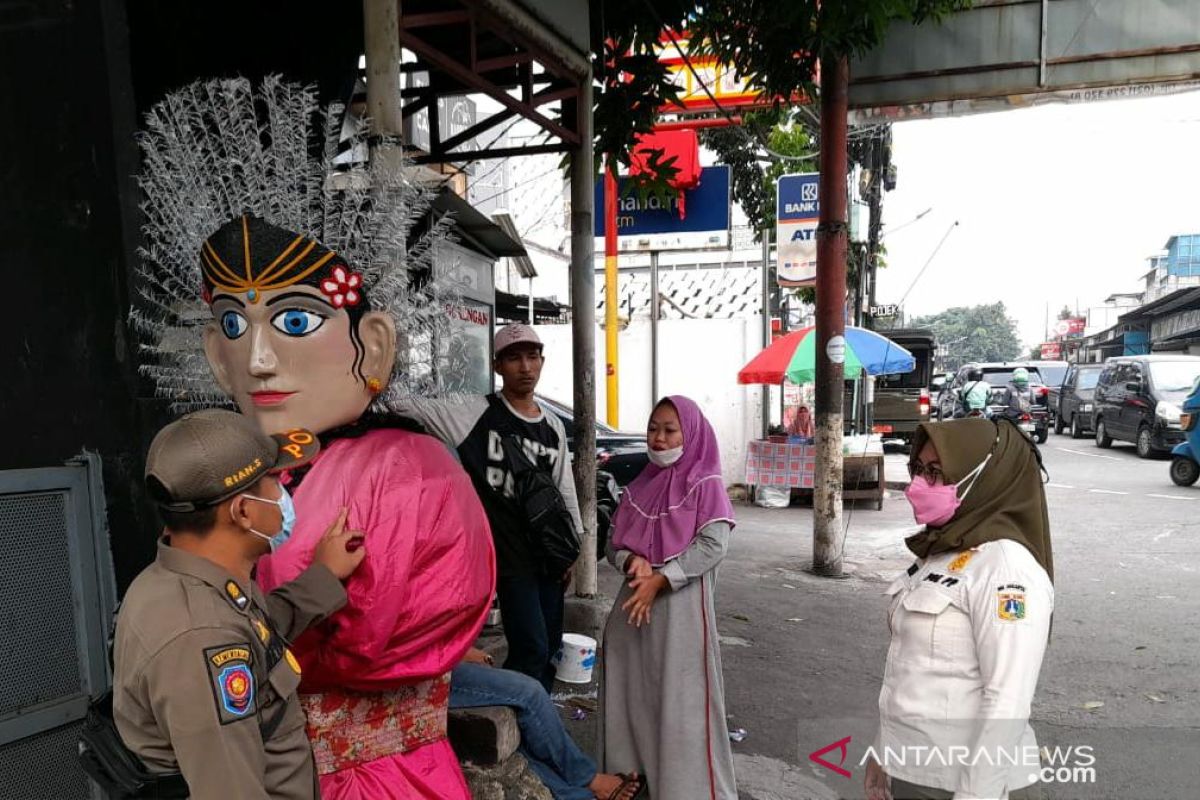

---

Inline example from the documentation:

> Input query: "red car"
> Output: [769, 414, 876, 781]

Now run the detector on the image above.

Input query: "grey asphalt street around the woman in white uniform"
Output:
[696, 434, 1200, 800]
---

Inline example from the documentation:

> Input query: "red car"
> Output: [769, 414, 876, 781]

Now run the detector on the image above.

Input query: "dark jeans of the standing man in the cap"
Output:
[496, 576, 564, 692]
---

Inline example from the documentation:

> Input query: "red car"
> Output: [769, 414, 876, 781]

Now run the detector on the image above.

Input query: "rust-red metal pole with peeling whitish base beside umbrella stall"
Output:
[812, 58, 850, 576]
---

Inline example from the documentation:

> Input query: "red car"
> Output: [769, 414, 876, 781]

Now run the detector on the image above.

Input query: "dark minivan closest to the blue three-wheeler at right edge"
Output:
[1093, 355, 1200, 458]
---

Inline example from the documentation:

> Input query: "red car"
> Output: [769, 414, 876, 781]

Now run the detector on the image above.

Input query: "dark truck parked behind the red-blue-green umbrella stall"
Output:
[845, 327, 935, 445]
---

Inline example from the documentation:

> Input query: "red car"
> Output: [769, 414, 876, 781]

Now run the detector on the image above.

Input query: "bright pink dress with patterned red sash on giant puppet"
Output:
[258, 428, 496, 800]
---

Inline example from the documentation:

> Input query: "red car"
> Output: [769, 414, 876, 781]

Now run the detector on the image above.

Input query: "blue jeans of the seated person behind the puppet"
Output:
[450, 663, 596, 800]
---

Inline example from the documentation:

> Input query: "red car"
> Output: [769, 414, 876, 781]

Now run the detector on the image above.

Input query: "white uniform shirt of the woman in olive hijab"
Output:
[875, 540, 1054, 799]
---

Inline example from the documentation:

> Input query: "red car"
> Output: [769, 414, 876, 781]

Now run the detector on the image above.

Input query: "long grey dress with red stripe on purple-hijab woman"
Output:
[600, 522, 738, 800]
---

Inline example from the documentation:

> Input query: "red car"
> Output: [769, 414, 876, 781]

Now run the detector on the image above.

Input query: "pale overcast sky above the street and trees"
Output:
[877, 92, 1200, 345]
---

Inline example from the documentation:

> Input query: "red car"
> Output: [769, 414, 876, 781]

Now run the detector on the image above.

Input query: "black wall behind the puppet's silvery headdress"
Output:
[0, 0, 362, 591]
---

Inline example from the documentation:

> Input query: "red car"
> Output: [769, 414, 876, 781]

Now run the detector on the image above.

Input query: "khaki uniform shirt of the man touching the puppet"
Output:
[113, 540, 346, 800]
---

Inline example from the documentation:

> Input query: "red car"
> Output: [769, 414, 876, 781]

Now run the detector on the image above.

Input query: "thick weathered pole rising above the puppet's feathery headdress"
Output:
[362, 0, 403, 160]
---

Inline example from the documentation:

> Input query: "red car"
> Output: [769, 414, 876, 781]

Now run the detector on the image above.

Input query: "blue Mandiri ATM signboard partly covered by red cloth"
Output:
[595, 167, 730, 236]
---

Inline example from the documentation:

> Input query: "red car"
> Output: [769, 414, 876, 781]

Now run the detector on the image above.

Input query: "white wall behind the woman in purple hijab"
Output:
[538, 319, 779, 483]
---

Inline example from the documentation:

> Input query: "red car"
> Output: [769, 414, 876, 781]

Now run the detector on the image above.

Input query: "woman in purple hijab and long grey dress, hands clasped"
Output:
[601, 395, 738, 800]
